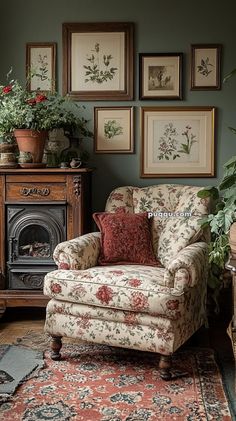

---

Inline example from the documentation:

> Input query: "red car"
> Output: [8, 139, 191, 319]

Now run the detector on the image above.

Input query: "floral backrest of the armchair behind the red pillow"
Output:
[105, 184, 210, 266]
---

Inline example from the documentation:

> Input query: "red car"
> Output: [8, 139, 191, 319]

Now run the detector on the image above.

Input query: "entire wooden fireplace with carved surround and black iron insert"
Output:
[0, 168, 92, 315]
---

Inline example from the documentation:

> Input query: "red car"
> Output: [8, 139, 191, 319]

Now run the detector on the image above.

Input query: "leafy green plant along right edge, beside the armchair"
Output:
[198, 69, 236, 299]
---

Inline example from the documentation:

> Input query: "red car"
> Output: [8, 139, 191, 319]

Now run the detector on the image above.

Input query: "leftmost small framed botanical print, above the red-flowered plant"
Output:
[26, 42, 56, 92]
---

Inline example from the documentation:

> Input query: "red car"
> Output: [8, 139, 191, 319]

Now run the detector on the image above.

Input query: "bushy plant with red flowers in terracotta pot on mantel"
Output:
[0, 71, 91, 163]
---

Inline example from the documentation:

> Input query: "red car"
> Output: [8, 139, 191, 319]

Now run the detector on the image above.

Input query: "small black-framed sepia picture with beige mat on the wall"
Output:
[139, 53, 183, 100]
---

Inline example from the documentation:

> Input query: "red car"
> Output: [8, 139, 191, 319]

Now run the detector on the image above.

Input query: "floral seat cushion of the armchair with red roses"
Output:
[44, 265, 188, 320]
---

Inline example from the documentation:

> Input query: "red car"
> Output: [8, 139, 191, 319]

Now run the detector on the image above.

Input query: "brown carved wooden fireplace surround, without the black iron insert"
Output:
[0, 168, 92, 316]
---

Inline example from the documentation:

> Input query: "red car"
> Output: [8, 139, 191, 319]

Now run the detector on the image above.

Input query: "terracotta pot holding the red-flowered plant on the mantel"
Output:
[14, 129, 48, 163]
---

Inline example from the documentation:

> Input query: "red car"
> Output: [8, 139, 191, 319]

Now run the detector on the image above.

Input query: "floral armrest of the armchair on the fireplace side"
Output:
[53, 232, 100, 270]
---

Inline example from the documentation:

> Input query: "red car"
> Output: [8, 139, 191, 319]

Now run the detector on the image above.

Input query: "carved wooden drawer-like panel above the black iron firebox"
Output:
[6, 183, 66, 202]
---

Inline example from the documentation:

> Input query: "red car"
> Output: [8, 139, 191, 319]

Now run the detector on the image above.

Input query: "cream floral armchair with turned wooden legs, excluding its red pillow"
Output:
[44, 184, 209, 379]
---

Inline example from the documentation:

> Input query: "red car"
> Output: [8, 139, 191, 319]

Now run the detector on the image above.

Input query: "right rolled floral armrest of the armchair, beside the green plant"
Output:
[164, 241, 209, 291]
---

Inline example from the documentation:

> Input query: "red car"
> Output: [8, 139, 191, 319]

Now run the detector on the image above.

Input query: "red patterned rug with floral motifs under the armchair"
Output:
[0, 344, 231, 421]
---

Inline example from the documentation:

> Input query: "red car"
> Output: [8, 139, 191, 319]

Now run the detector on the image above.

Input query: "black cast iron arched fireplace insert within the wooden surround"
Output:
[6, 203, 66, 289]
